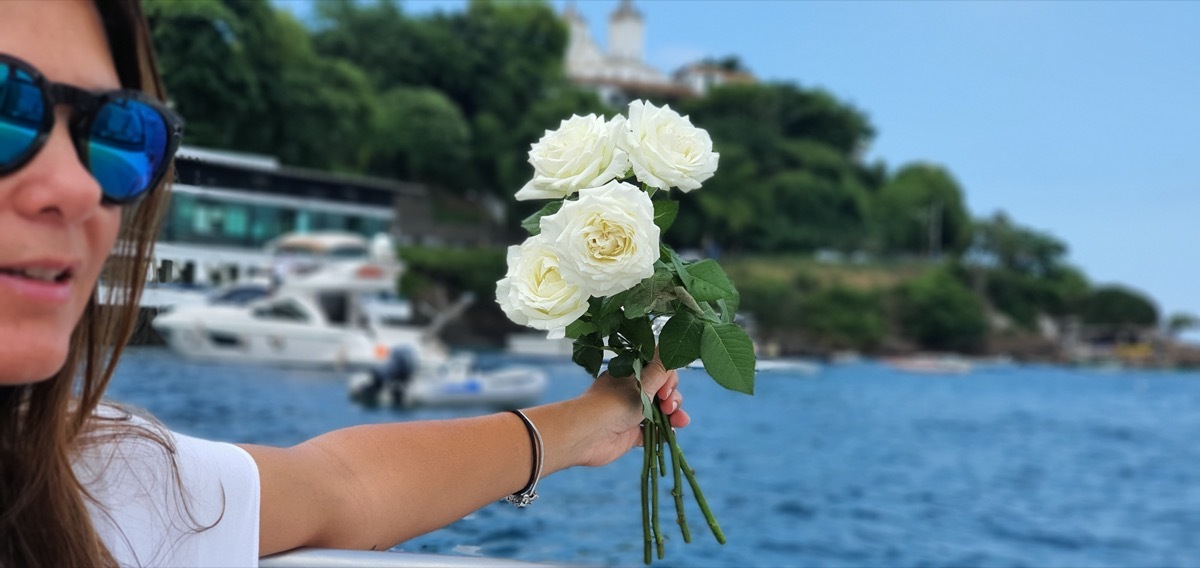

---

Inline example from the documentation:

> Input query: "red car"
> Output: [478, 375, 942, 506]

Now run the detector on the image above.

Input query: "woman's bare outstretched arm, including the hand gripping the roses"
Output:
[244, 360, 689, 556]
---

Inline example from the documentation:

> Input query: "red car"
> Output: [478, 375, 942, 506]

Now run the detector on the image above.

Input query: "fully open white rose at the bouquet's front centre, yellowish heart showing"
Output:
[541, 181, 659, 297]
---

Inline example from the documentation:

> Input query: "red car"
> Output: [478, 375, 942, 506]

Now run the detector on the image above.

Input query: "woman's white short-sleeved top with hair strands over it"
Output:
[74, 409, 260, 567]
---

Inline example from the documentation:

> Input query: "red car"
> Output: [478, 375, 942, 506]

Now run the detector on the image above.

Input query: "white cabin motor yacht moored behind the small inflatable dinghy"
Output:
[151, 233, 422, 369]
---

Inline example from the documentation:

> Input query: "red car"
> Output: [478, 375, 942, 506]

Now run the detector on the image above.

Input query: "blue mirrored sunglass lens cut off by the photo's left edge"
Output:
[0, 62, 46, 168]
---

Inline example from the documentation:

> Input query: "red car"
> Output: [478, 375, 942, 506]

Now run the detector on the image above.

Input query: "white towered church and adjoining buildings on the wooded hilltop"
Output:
[563, 0, 755, 106]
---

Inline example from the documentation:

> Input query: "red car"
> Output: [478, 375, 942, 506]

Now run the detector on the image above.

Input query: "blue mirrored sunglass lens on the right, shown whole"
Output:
[88, 98, 170, 202]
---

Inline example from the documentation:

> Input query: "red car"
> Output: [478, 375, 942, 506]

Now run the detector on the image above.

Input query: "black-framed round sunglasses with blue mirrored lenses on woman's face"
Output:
[0, 53, 184, 205]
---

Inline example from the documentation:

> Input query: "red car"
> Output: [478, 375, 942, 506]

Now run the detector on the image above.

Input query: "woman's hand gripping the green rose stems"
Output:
[577, 357, 691, 466]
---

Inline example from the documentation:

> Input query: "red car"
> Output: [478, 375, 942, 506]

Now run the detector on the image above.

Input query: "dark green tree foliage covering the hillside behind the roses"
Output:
[144, 0, 1161, 349]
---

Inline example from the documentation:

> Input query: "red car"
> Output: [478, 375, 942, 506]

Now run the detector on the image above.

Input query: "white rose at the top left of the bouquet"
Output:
[516, 114, 629, 201]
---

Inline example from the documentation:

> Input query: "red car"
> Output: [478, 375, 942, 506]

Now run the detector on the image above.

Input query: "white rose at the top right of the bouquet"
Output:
[622, 101, 720, 192]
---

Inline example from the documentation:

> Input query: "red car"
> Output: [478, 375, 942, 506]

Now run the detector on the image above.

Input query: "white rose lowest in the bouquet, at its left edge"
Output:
[496, 237, 588, 339]
